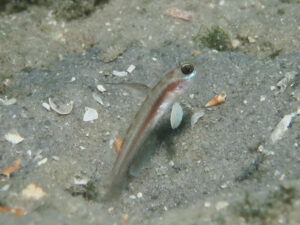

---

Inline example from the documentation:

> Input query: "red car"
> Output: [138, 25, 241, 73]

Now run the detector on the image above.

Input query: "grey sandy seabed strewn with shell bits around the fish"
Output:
[0, 1, 300, 225]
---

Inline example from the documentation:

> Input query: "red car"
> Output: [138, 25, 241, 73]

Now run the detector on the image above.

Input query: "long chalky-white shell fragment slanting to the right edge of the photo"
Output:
[270, 108, 300, 143]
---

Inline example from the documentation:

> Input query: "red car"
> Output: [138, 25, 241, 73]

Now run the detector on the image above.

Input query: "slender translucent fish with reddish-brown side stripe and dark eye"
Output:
[112, 63, 196, 189]
